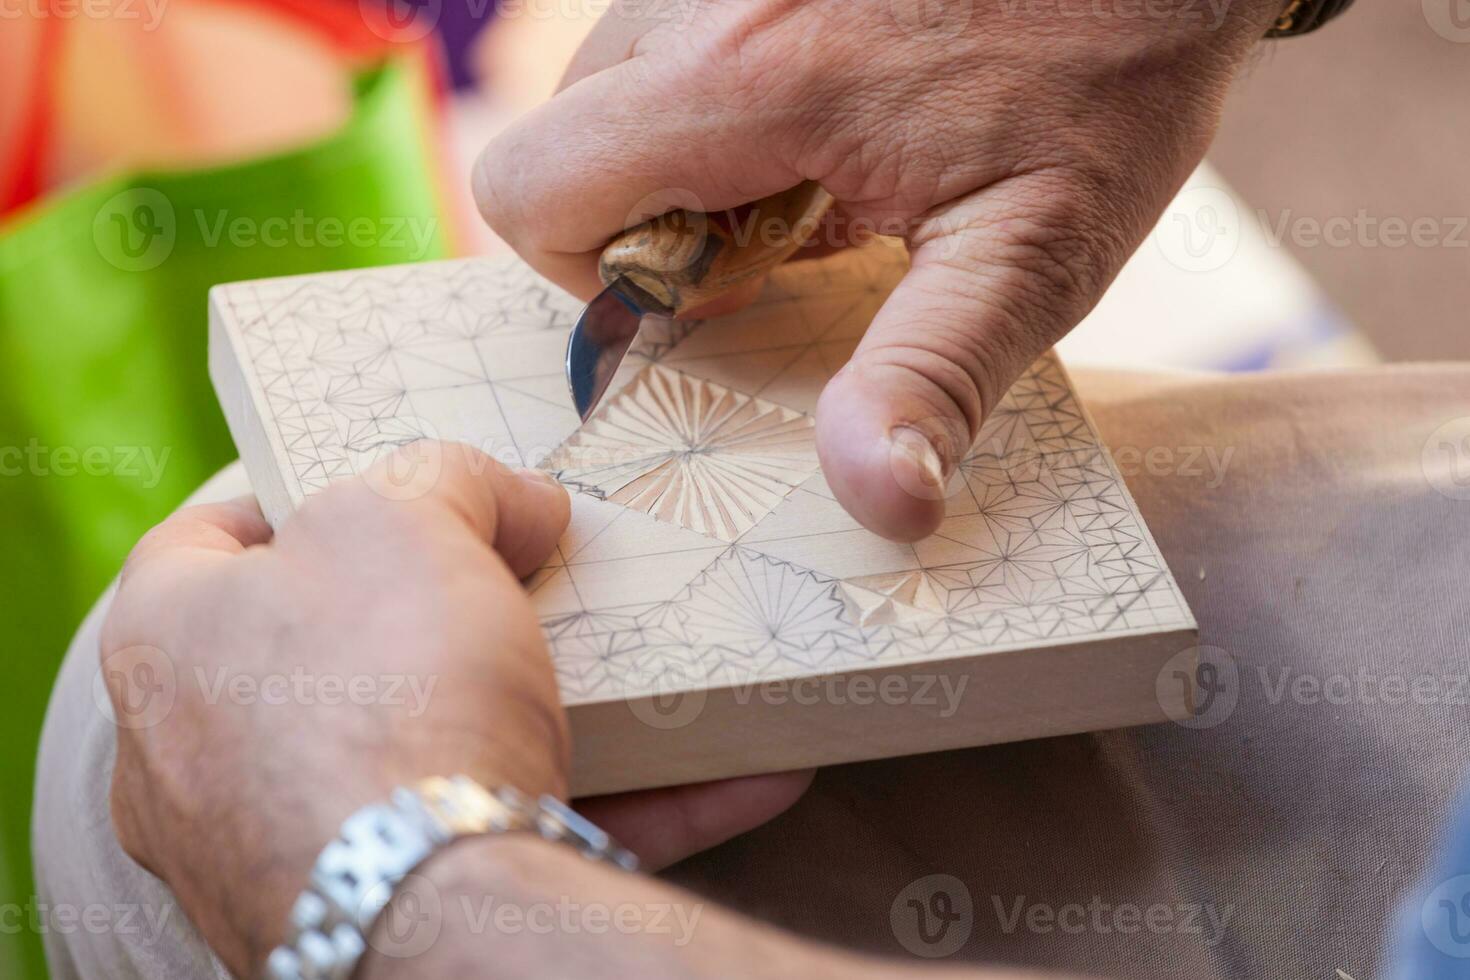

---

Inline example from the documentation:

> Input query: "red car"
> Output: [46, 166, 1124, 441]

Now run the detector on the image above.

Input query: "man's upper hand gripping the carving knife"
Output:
[475, 0, 1283, 539]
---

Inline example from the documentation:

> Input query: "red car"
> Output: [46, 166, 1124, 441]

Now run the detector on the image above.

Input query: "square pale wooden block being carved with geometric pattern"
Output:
[210, 244, 1195, 795]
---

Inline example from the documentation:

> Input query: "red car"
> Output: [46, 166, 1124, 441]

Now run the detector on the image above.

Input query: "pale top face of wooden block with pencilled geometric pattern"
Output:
[216, 244, 1194, 704]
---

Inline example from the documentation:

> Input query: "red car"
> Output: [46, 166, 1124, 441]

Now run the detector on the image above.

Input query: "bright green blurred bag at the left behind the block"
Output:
[0, 63, 450, 977]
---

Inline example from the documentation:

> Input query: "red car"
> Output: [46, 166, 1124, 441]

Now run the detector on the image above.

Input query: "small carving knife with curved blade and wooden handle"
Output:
[566, 181, 832, 422]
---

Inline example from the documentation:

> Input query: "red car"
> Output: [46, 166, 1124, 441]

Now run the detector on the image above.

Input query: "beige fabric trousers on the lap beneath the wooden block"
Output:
[35, 366, 1470, 980]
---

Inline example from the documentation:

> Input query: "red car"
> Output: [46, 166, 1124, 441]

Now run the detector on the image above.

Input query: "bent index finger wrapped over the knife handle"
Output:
[473, 39, 809, 300]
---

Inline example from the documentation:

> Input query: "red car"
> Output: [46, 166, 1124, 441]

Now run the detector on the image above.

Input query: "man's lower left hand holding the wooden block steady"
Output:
[100, 442, 810, 976]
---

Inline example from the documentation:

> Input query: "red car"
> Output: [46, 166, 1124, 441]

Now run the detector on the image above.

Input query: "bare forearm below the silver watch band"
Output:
[359, 835, 1034, 980]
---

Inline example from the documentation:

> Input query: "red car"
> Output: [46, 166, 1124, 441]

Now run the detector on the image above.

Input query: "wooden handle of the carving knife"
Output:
[598, 181, 832, 316]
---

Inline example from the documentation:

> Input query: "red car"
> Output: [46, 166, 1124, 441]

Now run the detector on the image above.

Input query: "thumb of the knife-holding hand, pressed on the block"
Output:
[816, 178, 1122, 541]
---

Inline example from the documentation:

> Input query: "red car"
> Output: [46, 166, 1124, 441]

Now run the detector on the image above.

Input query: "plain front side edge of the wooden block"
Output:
[567, 629, 1198, 795]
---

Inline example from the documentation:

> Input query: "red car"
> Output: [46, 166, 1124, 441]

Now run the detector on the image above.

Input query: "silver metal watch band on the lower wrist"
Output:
[263, 776, 638, 980]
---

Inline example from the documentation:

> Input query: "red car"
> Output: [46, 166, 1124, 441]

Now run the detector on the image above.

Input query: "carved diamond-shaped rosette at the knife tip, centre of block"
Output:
[547, 364, 817, 541]
